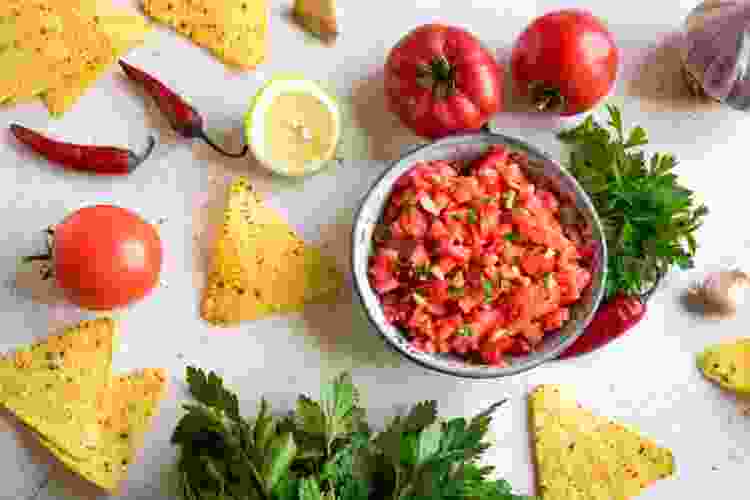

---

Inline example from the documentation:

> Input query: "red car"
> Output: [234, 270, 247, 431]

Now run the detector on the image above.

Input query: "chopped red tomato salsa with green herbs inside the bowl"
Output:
[369, 146, 592, 366]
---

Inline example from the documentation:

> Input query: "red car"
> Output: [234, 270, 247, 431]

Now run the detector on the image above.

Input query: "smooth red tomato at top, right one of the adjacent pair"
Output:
[511, 9, 619, 116]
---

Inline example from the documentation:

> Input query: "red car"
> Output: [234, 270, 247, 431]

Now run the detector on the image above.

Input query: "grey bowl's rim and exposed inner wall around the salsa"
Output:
[352, 132, 607, 378]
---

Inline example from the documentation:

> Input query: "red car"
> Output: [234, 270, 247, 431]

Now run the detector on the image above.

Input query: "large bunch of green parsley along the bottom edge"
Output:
[172, 367, 530, 500]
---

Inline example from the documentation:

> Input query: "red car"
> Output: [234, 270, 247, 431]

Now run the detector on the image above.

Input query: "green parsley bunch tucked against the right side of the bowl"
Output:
[558, 105, 708, 297]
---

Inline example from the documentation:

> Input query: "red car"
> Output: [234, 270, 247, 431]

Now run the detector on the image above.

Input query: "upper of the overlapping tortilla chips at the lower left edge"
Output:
[0, 318, 116, 459]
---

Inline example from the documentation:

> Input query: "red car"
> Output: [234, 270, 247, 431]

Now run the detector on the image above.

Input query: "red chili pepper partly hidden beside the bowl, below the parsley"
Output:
[558, 295, 646, 359]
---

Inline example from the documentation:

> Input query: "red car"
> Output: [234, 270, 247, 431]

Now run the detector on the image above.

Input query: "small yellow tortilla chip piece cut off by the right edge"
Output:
[698, 338, 750, 394]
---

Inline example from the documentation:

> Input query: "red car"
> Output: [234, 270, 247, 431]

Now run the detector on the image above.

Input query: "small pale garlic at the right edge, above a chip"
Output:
[688, 269, 750, 318]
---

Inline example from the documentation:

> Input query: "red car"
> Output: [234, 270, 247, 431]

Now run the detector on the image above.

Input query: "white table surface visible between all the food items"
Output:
[0, 0, 750, 500]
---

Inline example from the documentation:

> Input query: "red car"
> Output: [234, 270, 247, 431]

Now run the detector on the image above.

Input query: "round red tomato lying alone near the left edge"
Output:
[54, 205, 162, 310]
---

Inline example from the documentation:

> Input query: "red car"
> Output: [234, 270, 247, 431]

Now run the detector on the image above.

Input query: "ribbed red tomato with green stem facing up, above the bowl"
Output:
[385, 24, 503, 139]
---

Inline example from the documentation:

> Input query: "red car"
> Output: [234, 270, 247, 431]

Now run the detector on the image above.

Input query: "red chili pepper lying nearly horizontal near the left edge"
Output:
[10, 123, 156, 175]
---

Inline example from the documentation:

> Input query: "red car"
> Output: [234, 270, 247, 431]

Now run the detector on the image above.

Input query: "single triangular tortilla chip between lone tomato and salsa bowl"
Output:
[201, 177, 343, 326]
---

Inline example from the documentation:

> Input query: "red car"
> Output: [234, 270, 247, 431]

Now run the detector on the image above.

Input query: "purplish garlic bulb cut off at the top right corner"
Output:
[682, 0, 750, 110]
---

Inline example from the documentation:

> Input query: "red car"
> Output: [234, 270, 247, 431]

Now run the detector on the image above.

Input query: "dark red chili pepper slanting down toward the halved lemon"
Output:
[119, 61, 248, 158]
